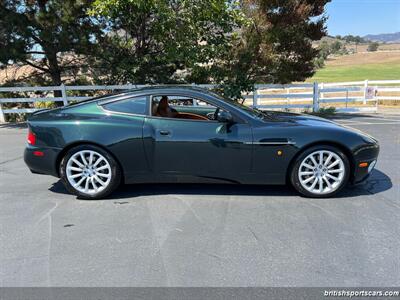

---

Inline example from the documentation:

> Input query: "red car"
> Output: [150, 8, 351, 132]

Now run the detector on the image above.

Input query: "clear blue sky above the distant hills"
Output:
[326, 0, 400, 36]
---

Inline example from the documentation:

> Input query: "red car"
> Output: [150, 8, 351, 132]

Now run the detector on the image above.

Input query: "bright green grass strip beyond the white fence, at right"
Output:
[307, 62, 400, 82]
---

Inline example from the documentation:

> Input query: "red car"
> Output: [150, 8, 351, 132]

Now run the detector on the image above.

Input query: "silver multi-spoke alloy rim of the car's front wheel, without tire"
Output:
[298, 150, 346, 195]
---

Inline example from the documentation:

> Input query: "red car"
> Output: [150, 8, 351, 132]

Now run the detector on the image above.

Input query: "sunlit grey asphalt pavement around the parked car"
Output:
[0, 115, 400, 287]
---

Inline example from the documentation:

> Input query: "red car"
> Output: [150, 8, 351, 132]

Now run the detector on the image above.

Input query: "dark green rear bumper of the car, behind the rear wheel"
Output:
[24, 145, 60, 177]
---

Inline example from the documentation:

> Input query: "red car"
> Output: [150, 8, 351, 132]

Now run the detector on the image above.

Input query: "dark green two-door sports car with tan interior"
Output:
[25, 86, 379, 199]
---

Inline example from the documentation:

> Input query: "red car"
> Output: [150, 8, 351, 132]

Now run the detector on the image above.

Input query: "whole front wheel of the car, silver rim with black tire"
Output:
[290, 146, 350, 198]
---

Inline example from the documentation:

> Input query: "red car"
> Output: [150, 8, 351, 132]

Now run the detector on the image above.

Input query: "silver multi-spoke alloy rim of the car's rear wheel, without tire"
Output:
[66, 150, 111, 195]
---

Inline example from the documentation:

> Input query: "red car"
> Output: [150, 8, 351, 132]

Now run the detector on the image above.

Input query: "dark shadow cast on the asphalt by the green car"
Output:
[49, 170, 392, 200]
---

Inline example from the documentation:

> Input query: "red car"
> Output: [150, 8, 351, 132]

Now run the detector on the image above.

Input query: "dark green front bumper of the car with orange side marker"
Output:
[352, 144, 379, 184]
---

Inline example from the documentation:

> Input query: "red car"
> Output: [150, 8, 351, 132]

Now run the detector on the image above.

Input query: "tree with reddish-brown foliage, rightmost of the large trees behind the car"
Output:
[199, 0, 329, 98]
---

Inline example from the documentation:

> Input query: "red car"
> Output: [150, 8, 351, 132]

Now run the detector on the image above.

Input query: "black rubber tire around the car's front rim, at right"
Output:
[289, 145, 350, 198]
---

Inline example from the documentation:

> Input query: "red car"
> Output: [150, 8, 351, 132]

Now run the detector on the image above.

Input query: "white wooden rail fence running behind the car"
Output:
[0, 80, 400, 122]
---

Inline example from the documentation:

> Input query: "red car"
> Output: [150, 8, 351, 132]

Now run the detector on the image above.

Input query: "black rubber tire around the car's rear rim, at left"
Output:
[60, 144, 121, 200]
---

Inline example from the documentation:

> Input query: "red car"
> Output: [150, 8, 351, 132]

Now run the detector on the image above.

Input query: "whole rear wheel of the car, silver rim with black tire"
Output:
[60, 145, 121, 199]
